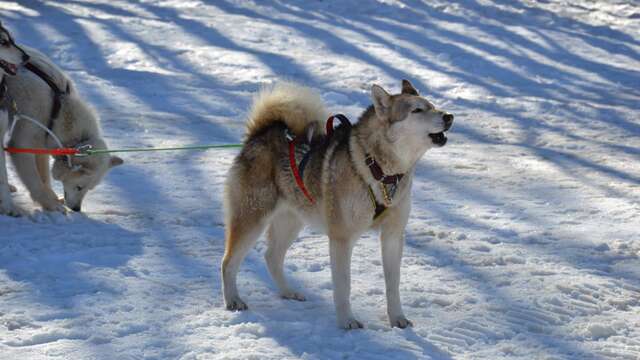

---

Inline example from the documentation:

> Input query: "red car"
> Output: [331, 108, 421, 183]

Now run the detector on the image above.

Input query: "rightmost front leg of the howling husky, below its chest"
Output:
[380, 199, 413, 328]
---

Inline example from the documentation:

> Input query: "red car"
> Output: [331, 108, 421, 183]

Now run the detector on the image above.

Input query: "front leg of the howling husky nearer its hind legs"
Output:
[329, 237, 364, 329]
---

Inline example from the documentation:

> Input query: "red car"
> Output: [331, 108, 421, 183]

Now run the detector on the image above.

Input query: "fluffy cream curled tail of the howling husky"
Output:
[246, 82, 328, 138]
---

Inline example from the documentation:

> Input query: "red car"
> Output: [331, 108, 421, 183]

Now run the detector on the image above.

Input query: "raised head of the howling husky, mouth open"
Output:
[371, 80, 453, 156]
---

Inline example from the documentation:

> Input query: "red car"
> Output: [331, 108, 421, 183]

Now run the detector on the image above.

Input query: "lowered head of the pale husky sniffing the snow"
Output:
[51, 140, 123, 211]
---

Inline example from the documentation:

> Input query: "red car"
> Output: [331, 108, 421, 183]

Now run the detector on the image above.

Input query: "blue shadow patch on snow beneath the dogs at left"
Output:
[0, 214, 142, 309]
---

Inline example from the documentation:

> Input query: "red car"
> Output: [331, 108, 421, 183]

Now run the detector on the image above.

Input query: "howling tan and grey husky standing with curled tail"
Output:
[222, 80, 453, 329]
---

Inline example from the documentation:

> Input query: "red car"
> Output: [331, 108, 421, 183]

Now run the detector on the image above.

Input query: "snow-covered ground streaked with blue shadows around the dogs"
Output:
[0, 0, 640, 359]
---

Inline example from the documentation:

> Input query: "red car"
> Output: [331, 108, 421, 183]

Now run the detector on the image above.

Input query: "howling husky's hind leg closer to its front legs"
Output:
[264, 210, 305, 301]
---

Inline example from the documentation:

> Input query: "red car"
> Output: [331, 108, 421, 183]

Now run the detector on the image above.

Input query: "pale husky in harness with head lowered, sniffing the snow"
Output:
[7, 46, 123, 213]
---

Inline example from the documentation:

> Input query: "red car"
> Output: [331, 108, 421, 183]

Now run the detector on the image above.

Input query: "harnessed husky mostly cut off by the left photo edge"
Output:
[0, 22, 27, 216]
